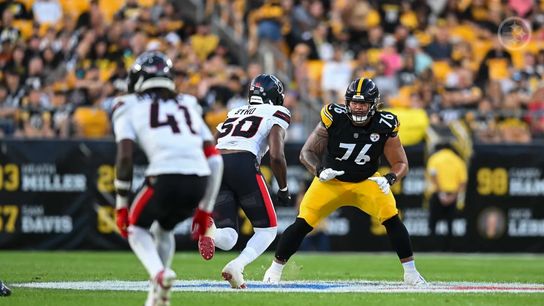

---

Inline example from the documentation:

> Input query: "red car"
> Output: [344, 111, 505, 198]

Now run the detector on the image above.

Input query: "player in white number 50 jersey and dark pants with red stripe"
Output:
[199, 74, 291, 288]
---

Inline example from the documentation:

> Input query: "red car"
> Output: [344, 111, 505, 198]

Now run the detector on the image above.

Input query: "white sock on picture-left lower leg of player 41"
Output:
[128, 225, 164, 278]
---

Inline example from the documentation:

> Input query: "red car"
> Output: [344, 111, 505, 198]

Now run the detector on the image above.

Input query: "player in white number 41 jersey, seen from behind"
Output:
[113, 52, 223, 306]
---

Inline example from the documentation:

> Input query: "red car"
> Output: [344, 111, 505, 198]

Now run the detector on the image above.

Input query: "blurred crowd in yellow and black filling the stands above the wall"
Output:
[0, 0, 544, 145]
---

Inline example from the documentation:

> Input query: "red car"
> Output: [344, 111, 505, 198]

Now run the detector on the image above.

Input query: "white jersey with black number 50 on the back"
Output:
[216, 104, 291, 163]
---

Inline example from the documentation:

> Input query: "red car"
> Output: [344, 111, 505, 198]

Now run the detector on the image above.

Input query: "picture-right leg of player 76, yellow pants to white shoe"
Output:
[351, 176, 426, 286]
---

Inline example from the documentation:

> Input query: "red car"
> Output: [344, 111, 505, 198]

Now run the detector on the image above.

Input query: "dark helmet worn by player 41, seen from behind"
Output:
[128, 51, 176, 93]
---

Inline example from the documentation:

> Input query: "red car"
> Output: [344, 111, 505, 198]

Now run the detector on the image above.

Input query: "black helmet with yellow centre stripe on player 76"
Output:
[345, 78, 381, 125]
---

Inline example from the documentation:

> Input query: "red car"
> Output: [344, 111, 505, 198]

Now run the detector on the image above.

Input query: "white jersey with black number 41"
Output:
[113, 95, 213, 176]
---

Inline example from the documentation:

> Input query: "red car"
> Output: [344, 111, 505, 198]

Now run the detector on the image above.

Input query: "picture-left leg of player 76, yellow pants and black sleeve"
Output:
[263, 178, 346, 283]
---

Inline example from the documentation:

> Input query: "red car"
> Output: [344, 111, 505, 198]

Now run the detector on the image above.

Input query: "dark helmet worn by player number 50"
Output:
[248, 74, 284, 105]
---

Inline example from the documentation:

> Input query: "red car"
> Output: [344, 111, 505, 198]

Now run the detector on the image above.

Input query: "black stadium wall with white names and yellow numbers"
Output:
[0, 140, 544, 252]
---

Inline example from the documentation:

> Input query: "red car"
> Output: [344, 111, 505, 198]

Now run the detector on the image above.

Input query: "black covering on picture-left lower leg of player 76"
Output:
[276, 218, 314, 262]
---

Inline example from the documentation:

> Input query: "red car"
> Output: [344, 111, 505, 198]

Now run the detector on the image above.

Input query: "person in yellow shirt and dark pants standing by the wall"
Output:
[426, 142, 467, 251]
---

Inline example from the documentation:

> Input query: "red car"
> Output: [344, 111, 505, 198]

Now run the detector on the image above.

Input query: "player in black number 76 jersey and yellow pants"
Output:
[264, 78, 426, 286]
